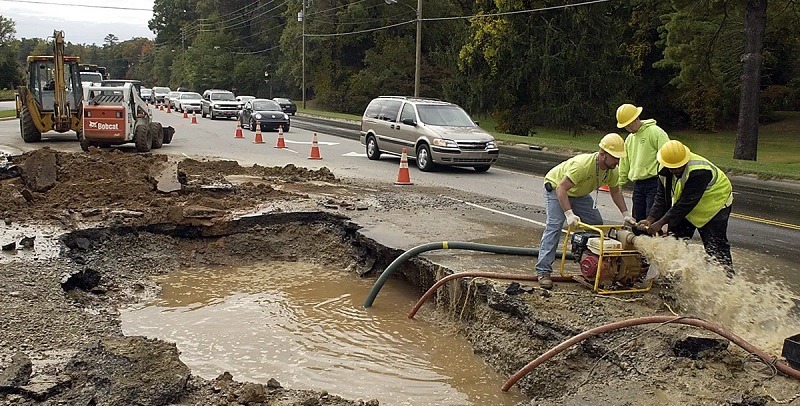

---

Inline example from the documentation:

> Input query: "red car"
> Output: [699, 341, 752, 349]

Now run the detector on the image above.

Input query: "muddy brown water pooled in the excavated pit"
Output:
[122, 262, 525, 405]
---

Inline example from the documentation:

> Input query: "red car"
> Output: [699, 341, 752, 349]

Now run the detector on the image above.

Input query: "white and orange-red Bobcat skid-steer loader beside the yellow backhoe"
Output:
[80, 83, 175, 152]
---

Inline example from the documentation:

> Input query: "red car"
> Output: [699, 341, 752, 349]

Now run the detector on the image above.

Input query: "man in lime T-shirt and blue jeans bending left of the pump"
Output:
[536, 133, 635, 289]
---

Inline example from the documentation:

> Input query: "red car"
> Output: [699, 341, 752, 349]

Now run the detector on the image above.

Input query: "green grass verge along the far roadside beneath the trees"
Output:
[298, 104, 800, 180]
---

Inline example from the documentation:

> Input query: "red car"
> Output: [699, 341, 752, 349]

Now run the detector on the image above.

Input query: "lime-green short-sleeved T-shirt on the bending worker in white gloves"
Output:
[544, 152, 619, 197]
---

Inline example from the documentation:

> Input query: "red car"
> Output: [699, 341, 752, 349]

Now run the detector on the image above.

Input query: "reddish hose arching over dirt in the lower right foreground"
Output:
[500, 316, 800, 392]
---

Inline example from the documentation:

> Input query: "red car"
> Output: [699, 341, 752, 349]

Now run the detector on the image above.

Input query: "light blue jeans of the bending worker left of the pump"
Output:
[536, 189, 603, 275]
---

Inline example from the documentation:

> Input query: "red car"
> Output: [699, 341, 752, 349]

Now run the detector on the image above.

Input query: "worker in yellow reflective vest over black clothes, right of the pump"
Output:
[639, 140, 733, 276]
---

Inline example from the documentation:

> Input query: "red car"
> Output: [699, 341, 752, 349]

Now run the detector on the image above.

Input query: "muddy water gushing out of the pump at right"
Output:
[634, 236, 800, 354]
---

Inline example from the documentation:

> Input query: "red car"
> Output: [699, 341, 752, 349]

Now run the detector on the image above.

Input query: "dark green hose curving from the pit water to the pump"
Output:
[364, 241, 573, 308]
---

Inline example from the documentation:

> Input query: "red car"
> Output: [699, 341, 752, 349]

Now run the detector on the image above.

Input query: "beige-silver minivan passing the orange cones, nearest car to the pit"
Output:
[361, 96, 500, 172]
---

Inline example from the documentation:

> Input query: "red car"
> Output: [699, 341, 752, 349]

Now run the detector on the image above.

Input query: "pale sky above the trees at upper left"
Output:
[0, 0, 155, 45]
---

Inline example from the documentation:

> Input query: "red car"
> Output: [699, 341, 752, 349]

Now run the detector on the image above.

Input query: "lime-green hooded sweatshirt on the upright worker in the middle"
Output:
[619, 119, 669, 185]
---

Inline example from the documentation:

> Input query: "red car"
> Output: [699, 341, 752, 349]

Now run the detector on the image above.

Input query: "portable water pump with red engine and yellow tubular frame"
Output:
[561, 223, 653, 294]
